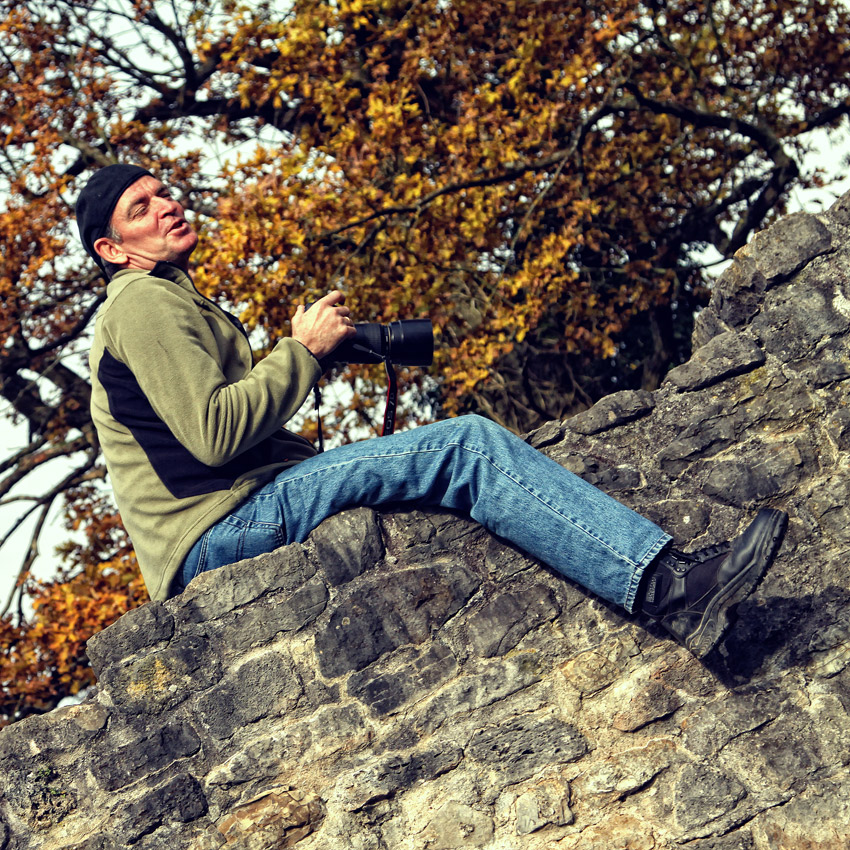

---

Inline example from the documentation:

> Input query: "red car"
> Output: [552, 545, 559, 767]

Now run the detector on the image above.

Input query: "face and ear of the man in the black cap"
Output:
[94, 176, 198, 271]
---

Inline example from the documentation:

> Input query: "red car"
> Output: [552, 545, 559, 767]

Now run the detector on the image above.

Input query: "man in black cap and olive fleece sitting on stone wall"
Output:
[77, 164, 787, 656]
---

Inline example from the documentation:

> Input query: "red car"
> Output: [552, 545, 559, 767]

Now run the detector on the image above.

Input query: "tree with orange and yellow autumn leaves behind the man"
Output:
[0, 0, 850, 720]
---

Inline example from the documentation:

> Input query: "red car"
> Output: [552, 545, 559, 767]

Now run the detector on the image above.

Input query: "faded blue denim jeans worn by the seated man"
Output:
[173, 416, 670, 611]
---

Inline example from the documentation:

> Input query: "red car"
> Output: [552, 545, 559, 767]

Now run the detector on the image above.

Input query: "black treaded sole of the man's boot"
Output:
[664, 508, 788, 658]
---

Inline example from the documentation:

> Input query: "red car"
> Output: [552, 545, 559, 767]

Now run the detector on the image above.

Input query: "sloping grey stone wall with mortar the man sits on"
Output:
[0, 196, 850, 850]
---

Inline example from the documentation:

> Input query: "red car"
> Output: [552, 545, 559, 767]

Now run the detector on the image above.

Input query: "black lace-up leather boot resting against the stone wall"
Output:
[640, 508, 788, 658]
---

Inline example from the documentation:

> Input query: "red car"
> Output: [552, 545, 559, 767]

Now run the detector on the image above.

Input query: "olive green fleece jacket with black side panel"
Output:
[90, 263, 321, 600]
